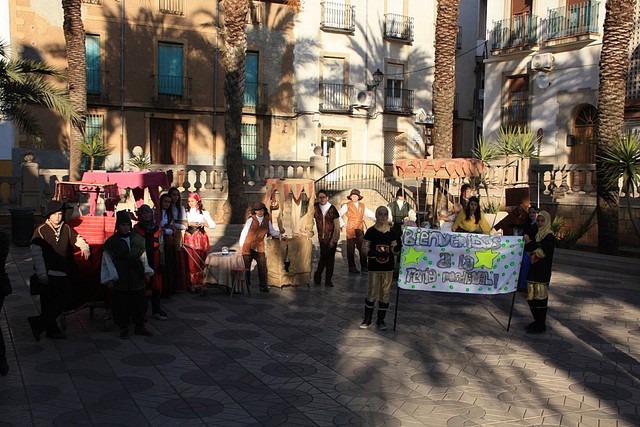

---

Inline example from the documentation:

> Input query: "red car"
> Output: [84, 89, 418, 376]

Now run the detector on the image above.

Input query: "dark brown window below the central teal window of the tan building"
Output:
[149, 119, 189, 165]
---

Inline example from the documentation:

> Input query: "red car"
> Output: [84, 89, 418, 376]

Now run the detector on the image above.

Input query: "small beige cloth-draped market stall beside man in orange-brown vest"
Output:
[265, 179, 315, 287]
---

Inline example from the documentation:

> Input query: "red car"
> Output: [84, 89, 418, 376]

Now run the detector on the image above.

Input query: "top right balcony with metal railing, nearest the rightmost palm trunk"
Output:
[542, 2, 600, 44]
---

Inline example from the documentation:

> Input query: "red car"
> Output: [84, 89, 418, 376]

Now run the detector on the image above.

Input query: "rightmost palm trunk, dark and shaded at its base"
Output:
[596, 0, 635, 253]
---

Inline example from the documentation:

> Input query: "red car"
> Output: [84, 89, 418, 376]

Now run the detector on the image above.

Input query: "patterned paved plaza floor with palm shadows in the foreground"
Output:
[0, 232, 640, 427]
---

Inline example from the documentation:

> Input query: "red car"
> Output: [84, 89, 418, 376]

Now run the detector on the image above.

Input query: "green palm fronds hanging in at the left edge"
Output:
[0, 42, 80, 138]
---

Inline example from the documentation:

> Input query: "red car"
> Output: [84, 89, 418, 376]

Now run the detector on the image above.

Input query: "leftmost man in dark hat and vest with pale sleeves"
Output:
[27, 200, 91, 341]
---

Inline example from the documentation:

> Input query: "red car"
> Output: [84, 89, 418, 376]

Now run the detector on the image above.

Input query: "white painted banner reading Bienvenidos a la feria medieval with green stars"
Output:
[398, 227, 524, 294]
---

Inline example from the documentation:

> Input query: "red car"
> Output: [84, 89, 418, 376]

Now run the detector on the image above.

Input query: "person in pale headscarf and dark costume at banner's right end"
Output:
[524, 211, 556, 333]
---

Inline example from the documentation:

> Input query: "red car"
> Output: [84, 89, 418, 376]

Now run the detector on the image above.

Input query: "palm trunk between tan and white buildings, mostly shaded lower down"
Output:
[221, 0, 249, 224]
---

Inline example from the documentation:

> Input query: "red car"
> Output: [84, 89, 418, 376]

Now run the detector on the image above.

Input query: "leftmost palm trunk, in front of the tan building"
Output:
[62, 0, 87, 181]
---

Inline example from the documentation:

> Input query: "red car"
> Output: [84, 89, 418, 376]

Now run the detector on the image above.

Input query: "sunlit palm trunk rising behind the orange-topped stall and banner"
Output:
[433, 0, 460, 159]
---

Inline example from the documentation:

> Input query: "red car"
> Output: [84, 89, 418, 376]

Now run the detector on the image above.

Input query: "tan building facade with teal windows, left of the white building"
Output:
[9, 0, 294, 174]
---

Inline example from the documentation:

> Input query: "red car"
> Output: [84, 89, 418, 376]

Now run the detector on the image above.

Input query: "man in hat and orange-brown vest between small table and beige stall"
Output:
[239, 202, 284, 292]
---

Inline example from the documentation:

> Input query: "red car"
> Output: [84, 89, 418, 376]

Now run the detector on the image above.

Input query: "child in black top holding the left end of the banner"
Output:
[360, 206, 400, 331]
